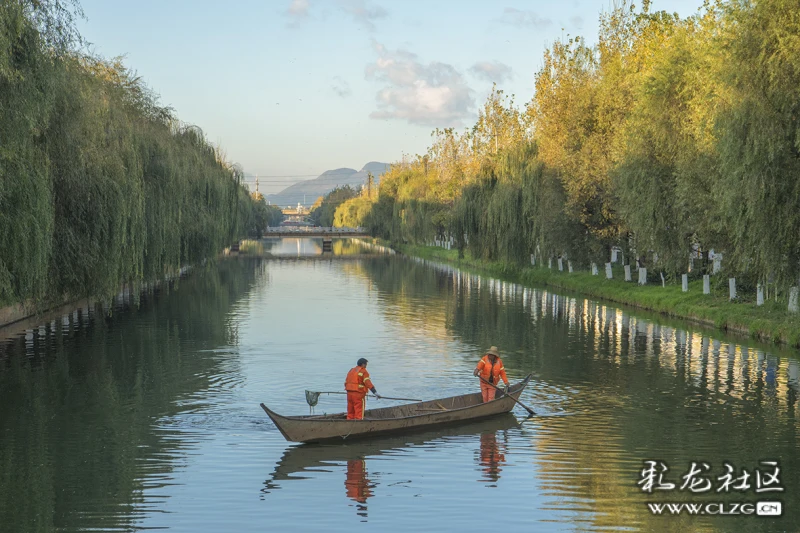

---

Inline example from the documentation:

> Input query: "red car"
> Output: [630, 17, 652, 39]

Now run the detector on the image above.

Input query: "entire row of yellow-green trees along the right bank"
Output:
[358, 0, 800, 304]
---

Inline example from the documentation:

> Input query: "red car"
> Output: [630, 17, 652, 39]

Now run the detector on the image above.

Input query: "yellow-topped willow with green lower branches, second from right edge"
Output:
[612, 12, 703, 272]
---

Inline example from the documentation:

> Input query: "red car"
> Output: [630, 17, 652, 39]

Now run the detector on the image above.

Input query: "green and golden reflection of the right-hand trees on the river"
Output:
[351, 258, 800, 531]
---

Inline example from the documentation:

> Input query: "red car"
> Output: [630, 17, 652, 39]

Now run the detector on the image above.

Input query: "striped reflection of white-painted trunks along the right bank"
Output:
[353, 259, 800, 413]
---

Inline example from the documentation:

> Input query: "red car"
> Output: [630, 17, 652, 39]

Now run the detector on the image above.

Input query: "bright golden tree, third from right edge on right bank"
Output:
[529, 1, 684, 260]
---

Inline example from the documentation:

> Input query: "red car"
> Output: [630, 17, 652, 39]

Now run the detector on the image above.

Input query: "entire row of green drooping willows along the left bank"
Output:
[0, 5, 253, 305]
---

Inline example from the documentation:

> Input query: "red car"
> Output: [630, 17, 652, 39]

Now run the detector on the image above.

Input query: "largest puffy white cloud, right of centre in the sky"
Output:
[366, 41, 474, 127]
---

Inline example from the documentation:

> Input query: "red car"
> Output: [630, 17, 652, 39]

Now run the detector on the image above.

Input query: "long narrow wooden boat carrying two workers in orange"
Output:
[261, 374, 531, 442]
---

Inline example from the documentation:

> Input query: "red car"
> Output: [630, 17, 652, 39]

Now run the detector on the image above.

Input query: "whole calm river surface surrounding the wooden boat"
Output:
[0, 247, 800, 531]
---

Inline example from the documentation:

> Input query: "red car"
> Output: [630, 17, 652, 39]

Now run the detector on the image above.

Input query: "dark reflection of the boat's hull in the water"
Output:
[262, 413, 519, 493]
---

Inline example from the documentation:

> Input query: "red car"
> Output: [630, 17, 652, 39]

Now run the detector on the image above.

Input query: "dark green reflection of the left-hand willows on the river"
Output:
[0, 260, 262, 532]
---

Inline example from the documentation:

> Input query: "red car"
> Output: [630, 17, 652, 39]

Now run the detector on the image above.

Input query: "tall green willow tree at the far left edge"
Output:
[0, 1, 77, 304]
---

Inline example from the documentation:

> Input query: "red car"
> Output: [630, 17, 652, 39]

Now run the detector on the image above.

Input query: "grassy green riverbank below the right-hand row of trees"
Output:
[394, 245, 800, 348]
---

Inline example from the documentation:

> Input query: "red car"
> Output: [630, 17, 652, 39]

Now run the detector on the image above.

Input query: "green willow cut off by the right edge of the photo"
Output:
[717, 0, 800, 284]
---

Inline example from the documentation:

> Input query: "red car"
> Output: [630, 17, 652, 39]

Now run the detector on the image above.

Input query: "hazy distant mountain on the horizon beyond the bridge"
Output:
[267, 161, 389, 207]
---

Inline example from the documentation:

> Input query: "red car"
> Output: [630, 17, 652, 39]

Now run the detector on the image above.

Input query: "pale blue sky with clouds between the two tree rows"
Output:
[73, 0, 702, 193]
